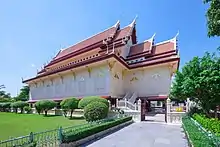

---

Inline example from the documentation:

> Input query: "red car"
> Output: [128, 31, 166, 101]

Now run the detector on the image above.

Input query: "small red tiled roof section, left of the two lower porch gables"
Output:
[128, 41, 152, 56]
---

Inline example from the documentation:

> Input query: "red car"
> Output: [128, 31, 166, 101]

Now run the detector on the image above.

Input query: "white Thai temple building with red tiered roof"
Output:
[22, 20, 180, 103]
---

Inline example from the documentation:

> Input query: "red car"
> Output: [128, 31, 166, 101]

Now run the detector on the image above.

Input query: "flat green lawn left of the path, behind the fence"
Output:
[0, 112, 85, 140]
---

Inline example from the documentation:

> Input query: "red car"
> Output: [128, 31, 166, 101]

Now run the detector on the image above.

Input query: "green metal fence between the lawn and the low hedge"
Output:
[0, 116, 120, 147]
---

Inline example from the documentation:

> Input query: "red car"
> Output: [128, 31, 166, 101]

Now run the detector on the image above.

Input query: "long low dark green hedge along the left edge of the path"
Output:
[62, 117, 132, 143]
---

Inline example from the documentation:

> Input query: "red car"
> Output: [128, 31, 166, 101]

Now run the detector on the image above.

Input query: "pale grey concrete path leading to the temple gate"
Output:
[81, 122, 188, 147]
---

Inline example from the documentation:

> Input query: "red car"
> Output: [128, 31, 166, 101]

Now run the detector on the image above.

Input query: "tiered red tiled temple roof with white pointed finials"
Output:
[23, 19, 179, 83]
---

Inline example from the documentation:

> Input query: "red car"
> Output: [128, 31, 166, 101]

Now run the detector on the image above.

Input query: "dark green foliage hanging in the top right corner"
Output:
[204, 0, 220, 37]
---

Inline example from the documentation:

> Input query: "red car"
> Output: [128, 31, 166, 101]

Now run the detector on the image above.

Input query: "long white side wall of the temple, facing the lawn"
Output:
[29, 65, 110, 100]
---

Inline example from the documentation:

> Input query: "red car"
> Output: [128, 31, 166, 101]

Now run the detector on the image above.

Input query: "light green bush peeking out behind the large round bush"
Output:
[78, 96, 109, 109]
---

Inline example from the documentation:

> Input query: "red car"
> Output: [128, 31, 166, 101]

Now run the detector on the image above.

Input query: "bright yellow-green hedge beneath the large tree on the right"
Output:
[193, 114, 220, 137]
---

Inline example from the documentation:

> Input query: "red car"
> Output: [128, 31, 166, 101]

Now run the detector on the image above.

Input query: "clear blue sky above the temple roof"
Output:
[0, 0, 220, 96]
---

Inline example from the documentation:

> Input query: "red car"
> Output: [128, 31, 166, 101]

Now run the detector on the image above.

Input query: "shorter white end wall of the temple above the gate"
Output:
[123, 66, 171, 97]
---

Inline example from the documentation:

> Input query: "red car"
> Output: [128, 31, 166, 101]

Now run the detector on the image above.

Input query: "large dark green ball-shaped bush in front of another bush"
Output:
[84, 102, 108, 122]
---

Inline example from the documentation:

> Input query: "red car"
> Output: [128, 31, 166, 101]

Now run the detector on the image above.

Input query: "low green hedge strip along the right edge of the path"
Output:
[182, 116, 215, 147]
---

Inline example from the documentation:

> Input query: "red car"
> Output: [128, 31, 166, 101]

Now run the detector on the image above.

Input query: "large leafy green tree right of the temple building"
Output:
[171, 52, 220, 116]
